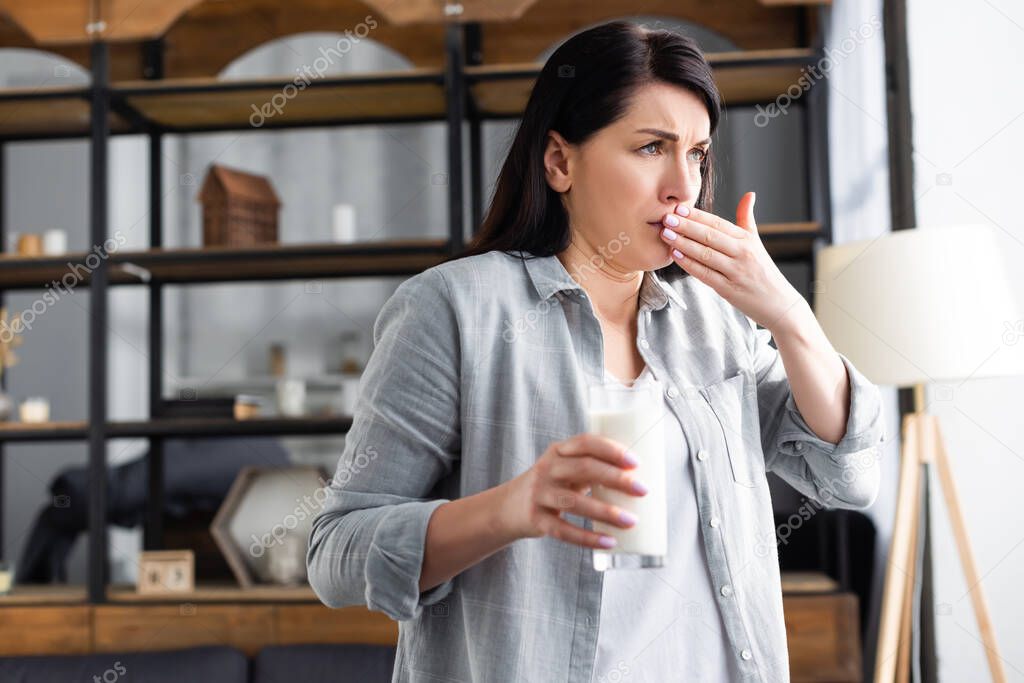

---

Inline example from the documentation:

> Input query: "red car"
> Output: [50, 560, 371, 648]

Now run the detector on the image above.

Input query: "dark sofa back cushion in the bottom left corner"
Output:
[0, 646, 249, 683]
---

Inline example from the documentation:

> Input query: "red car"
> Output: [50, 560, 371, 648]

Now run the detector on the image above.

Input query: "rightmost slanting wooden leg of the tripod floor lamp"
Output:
[931, 420, 1007, 683]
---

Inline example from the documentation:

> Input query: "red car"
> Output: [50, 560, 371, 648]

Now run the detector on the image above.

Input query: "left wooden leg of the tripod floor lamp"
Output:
[874, 413, 922, 683]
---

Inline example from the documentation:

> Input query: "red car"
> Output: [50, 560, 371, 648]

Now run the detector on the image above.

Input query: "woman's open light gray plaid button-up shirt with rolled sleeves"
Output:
[307, 252, 884, 683]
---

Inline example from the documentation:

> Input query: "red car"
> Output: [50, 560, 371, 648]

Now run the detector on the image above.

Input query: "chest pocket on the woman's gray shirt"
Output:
[699, 371, 765, 488]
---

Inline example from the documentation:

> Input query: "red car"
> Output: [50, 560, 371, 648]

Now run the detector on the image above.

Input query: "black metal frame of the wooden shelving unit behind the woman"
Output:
[0, 15, 830, 603]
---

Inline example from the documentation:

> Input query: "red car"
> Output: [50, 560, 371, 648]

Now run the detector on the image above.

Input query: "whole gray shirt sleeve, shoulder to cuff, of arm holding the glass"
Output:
[306, 269, 461, 621]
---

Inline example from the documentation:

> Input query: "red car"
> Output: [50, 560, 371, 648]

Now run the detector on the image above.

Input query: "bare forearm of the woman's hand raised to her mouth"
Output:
[771, 301, 850, 443]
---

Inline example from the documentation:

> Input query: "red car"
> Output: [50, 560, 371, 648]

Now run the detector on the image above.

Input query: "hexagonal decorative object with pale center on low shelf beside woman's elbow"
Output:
[210, 466, 328, 588]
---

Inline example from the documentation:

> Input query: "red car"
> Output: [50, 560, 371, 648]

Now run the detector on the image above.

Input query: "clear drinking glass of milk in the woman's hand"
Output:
[587, 376, 669, 571]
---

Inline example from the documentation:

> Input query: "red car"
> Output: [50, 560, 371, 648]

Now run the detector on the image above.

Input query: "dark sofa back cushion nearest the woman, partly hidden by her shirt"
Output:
[253, 644, 394, 683]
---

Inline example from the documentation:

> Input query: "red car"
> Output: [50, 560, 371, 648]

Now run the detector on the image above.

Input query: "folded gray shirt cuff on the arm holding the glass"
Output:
[366, 499, 454, 622]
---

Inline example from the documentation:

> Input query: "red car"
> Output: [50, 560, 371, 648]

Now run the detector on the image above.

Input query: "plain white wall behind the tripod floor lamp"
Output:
[908, 0, 1024, 681]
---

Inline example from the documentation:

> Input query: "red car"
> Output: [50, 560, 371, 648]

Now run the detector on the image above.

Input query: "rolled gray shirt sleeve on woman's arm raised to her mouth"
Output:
[748, 318, 886, 510]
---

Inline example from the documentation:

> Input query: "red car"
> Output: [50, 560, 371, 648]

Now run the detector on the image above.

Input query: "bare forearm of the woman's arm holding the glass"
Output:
[420, 485, 518, 593]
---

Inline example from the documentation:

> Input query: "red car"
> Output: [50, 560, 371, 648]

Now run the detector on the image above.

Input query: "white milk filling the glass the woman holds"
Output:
[587, 403, 669, 557]
